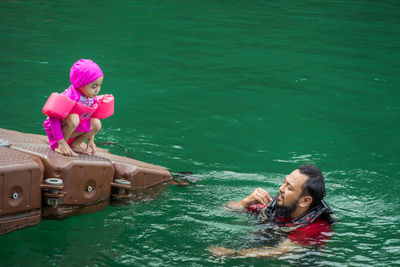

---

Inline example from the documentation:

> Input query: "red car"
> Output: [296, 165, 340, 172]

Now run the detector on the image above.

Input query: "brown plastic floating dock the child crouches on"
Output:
[0, 128, 172, 235]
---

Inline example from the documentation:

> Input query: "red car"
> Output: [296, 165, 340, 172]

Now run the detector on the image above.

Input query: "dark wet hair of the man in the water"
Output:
[298, 164, 326, 208]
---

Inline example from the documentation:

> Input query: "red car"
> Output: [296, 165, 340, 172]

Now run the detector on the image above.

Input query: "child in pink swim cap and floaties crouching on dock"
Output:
[43, 59, 114, 156]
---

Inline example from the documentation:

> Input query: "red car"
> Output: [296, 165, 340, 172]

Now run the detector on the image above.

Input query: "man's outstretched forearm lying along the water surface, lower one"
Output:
[209, 239, 302, 258]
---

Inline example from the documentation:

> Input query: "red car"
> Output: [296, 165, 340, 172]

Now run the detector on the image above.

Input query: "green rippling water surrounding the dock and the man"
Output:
[0, 0, 400, 266]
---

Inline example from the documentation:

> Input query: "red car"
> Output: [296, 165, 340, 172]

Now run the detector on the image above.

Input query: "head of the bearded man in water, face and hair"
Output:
[277, 164, 325, 218]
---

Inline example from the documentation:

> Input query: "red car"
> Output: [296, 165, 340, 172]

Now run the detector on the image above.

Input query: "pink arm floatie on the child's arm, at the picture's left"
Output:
[42, 93, 75, 120]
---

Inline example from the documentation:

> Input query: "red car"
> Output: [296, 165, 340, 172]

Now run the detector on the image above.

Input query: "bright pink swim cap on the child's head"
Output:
[69, 59, 104, 89]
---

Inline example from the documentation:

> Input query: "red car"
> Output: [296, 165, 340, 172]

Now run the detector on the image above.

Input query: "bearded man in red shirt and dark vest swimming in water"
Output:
[209, 164, 337, 257]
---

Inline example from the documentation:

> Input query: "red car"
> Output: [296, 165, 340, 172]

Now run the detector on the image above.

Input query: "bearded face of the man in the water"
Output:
[277, 169, 308, 217]
